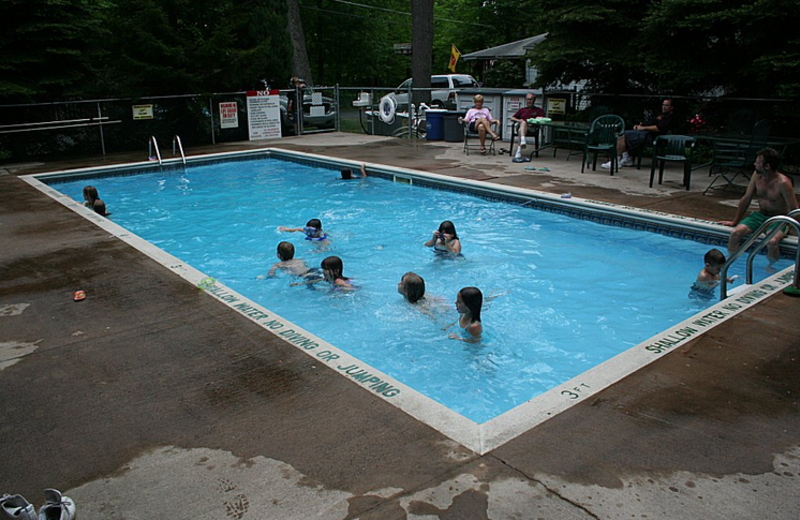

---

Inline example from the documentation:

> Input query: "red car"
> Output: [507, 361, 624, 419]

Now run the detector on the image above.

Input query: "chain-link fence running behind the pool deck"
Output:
[0, 86, 800, 172]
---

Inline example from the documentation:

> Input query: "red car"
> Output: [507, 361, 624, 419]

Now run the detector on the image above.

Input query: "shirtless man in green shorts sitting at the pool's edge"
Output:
[720, 148, 797, 263]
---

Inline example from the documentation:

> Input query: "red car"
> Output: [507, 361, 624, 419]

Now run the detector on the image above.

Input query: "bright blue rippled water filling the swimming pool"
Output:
[50, 159, 788, 423]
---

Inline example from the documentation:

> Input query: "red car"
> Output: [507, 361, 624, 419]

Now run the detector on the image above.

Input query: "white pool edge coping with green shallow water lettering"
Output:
[19, 148, 796, 455]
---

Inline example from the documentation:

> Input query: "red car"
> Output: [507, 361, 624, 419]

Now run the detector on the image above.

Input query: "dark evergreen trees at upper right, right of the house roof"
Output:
[532, 0, 800, 97]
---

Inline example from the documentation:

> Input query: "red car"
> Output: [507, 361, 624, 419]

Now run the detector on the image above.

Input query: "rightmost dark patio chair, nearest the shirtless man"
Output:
[703, 119, 772, 194]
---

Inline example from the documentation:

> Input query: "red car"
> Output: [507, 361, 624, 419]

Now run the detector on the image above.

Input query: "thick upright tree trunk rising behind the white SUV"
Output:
[411, 0, 433, 106]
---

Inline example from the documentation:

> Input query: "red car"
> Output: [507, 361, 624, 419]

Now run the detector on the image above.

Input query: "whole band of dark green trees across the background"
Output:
[0, 0, 800, 103]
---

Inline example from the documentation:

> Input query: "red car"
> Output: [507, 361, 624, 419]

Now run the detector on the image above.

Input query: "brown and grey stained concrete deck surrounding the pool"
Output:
[0, 134, 800, 520]
